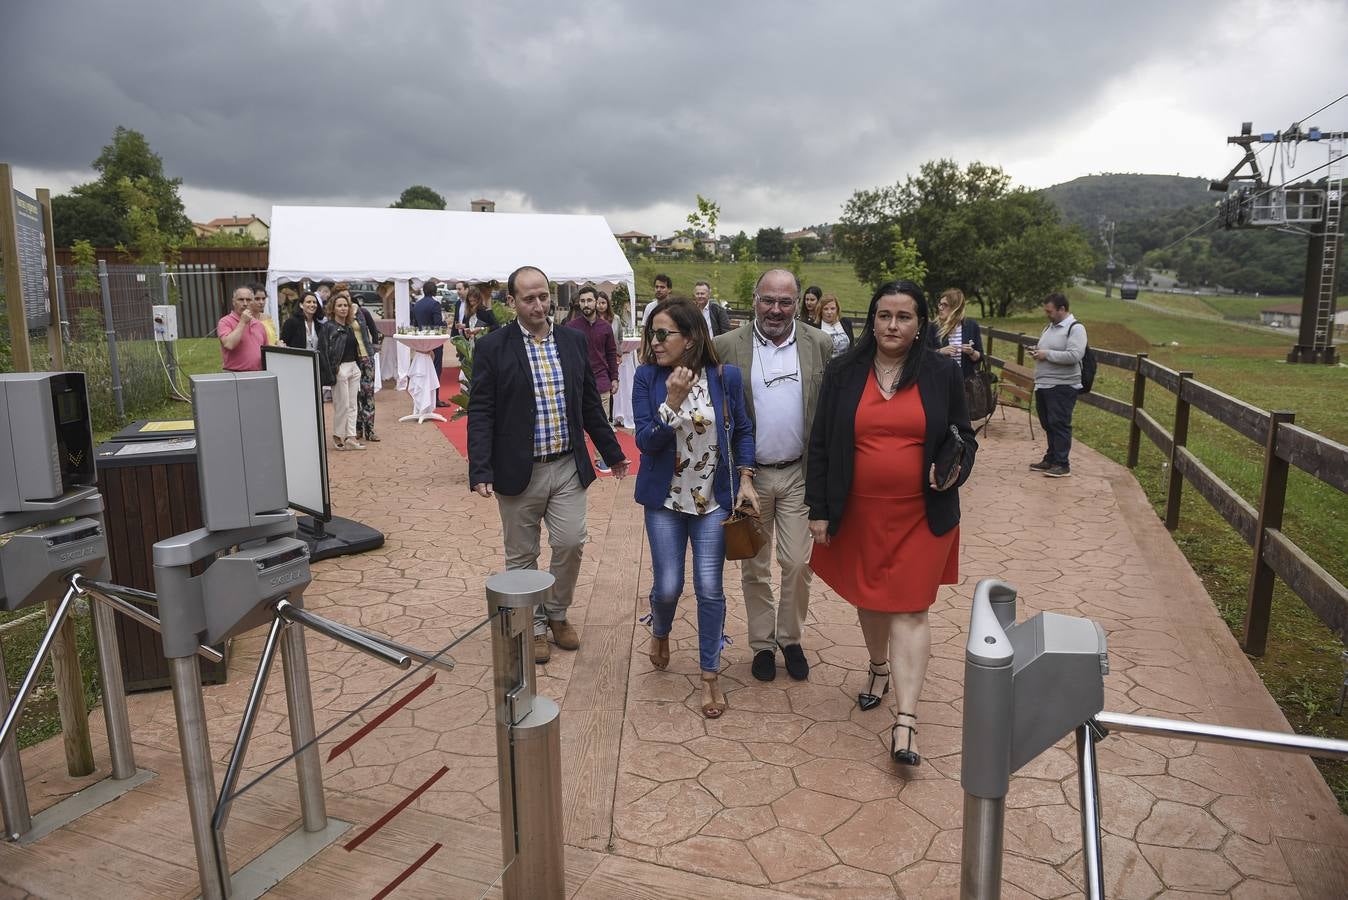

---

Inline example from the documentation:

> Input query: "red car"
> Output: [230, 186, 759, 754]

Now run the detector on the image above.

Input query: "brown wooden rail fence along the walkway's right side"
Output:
[987, 329, 1348, 656]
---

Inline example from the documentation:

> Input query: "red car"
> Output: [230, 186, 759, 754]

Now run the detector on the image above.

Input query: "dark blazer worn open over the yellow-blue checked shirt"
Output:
[468, 322, 627, 497]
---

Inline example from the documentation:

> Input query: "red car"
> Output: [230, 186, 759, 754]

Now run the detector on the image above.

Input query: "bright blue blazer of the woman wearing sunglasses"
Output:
[632, 364, 754, 509]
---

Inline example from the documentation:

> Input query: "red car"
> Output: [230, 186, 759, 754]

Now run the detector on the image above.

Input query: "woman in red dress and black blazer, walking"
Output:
[805, 282, 977, 765]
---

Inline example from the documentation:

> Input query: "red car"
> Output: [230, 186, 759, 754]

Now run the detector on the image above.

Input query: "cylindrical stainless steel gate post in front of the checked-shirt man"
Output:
[487, 569, 566, 900]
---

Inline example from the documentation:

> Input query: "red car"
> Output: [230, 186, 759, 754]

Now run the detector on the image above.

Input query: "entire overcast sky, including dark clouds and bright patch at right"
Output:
[0, 0, 1348, 234]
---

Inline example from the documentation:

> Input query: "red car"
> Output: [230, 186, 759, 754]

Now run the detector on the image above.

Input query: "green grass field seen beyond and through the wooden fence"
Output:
[991, 290, 1348, 811]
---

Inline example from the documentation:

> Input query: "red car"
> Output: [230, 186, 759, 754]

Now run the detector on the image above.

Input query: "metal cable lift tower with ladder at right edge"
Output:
[1209, 123, 1348, 365]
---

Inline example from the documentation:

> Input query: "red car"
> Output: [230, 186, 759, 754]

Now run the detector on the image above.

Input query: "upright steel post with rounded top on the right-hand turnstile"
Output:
[960, 579, 1015, 900]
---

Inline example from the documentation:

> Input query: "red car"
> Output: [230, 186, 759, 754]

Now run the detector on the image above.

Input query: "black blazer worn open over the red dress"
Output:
[805, 349, 979, 535]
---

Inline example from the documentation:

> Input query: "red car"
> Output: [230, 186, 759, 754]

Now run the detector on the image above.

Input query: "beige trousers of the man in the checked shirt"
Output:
[496, 457, 586, 635]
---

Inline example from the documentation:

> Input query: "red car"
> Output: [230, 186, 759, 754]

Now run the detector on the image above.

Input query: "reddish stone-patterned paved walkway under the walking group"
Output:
[0, 392, 1348, 900]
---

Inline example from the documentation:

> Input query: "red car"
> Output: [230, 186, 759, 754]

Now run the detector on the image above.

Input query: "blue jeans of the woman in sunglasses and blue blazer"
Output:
[646, 507, 729, 672]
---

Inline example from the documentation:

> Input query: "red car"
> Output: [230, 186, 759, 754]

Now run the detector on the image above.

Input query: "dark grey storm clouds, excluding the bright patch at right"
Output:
[0, 0, 1229, 218]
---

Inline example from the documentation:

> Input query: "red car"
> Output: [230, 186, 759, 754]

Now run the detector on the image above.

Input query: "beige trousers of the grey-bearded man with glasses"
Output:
[740, 463, 814, 653]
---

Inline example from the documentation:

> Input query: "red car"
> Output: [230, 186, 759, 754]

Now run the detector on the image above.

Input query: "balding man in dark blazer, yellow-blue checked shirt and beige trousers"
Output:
[468, 265, 628, 663]
